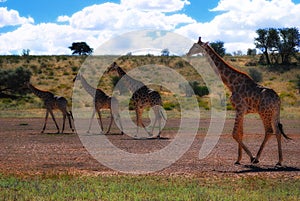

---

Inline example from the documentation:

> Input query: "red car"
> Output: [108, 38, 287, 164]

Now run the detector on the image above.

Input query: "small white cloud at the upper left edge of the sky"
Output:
[0, 7, 34, 28]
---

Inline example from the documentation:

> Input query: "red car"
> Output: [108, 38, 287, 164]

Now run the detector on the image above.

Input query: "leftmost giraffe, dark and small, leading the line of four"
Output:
[26, 82, 74, 133]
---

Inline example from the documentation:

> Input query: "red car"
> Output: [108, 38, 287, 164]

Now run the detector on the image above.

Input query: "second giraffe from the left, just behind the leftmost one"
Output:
[73, 73, 123, 134]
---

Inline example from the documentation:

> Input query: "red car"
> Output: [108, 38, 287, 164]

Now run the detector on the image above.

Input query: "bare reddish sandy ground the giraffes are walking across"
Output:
[0, 118, 300, 178]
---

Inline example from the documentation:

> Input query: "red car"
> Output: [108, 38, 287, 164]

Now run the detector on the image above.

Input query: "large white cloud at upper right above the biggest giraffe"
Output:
[176, 0, 300, 52]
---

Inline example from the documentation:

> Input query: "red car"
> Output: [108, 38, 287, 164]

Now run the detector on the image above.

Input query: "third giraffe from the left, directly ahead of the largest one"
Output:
[107, 62, 165, 138]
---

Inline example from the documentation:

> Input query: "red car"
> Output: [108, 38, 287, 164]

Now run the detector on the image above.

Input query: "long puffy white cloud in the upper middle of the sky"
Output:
[63, 1, 195, 32]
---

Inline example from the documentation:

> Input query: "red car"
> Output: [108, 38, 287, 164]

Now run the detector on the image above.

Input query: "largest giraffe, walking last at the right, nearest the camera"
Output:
[187, 37, 291, 166]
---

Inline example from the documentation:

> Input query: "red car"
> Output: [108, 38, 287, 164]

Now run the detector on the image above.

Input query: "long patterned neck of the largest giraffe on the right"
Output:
[203, 45, 255, 91]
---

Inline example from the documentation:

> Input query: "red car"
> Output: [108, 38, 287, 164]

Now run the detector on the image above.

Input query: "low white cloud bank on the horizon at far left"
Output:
[0, 23, 102, 55]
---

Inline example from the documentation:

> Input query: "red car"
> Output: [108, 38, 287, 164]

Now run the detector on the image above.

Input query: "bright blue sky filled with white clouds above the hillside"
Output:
[0, 0, 300, 54]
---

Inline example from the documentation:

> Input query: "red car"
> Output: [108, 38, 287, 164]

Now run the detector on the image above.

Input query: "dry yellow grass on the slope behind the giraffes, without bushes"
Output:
[0, 56, 300, 116]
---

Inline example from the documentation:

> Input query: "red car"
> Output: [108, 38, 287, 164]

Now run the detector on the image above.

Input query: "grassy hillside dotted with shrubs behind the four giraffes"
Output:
[0, 55, 300, 117]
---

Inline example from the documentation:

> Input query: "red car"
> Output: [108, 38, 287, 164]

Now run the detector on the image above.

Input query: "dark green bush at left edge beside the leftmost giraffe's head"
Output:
[0, 67, 31, 97]
